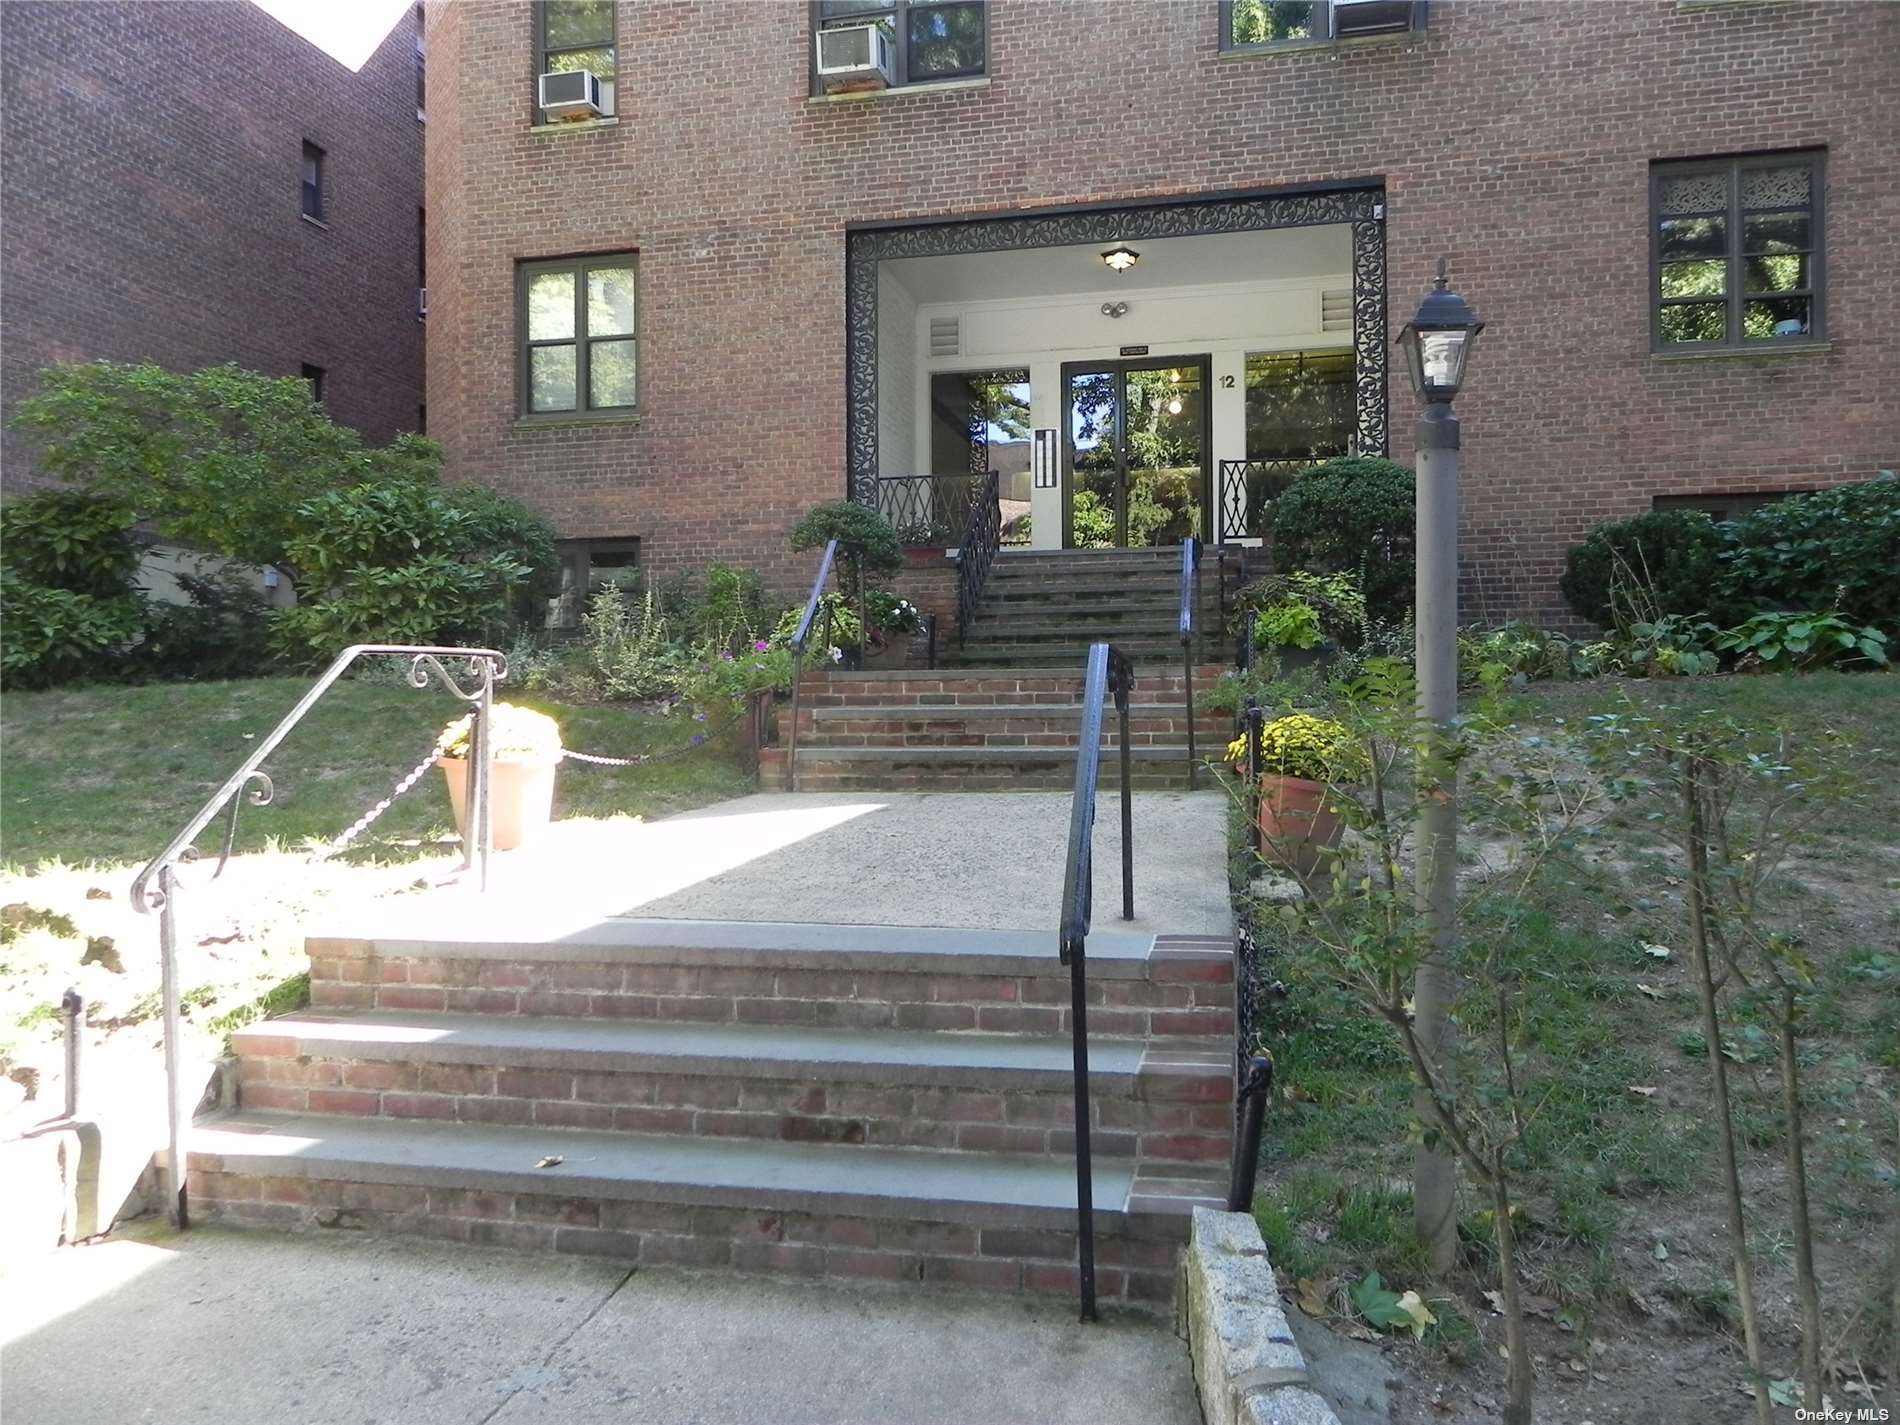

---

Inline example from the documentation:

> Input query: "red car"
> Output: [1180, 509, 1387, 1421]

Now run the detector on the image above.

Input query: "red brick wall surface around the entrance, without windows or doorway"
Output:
[428, 0, 1900, 618]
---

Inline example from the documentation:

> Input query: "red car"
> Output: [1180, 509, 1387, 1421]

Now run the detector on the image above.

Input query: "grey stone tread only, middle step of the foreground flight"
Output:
[232, 1011, 1155, 1089]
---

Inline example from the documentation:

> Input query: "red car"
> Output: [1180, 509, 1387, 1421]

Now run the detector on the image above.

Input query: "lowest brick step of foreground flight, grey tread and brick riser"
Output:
[188, 1112, 1224, 1309]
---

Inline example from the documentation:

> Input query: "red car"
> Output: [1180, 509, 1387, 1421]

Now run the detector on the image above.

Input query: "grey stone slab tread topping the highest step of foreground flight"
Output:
[308, 927, 1165, 979]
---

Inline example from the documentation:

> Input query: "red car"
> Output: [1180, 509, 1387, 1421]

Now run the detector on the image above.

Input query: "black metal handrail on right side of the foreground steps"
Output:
[1056, 644, 1134, 1321]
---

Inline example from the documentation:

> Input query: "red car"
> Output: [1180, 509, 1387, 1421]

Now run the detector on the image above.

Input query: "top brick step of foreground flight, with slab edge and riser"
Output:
[308, 915, 1233, 1039]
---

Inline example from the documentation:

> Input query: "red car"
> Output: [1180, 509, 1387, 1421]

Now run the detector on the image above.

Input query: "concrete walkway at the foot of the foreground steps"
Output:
[0, 1224, 1201, 1425]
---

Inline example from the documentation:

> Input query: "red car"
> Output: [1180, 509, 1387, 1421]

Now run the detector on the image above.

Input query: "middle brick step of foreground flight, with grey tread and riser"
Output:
[232, 1007, 1233, 1163]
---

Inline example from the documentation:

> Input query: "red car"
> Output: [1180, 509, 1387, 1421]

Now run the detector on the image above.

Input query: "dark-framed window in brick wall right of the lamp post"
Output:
[1649, 152, 1824, 352]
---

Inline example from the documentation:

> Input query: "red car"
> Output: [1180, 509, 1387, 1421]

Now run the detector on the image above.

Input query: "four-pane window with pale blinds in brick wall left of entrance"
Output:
[517, 253, 638, 416]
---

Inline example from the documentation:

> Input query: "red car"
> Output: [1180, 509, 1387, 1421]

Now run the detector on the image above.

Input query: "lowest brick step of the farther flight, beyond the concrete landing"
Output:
[798, 741, 1218, 792]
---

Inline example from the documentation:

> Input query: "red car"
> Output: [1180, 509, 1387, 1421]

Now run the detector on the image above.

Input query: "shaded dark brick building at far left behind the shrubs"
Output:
[0, 0, 424, 488]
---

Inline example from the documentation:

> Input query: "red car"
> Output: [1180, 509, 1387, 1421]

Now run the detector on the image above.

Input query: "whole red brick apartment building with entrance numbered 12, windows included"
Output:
[428, 0, 1900, 618]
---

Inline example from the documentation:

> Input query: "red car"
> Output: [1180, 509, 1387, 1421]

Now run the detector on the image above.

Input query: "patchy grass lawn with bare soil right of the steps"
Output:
[1256, 673, 1900, 1419]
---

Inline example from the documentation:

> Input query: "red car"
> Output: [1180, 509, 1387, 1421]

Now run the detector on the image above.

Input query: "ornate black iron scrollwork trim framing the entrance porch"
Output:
[846, 188, 1385, 504]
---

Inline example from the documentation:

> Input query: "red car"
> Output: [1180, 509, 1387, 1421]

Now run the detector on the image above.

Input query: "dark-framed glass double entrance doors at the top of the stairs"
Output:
[1062, 355, 1210, 549]
